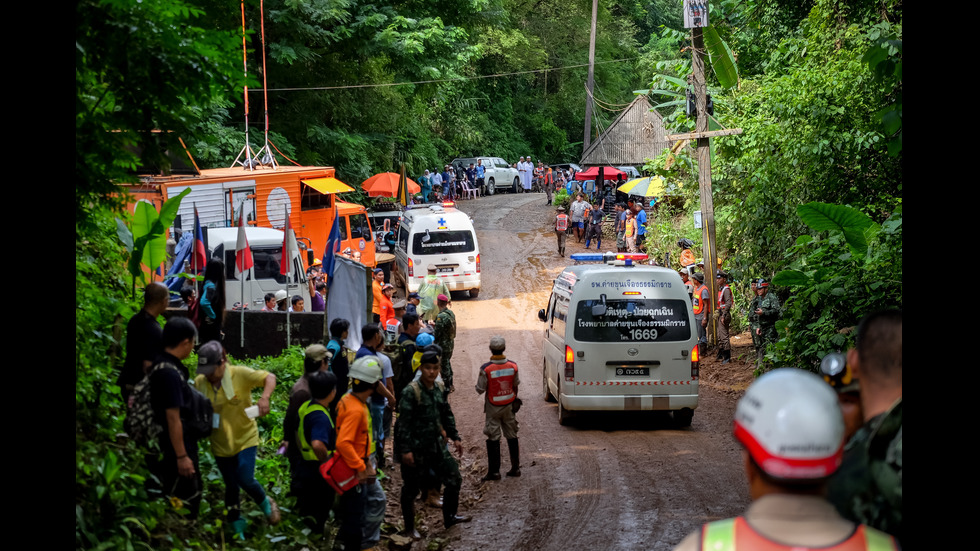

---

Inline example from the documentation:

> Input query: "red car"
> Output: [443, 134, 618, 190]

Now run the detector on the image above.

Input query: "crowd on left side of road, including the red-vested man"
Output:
[120, 258, 520, 550]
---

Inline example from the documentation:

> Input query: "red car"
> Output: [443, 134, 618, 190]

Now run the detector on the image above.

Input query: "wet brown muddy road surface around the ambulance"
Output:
[386, 194, 752, 551]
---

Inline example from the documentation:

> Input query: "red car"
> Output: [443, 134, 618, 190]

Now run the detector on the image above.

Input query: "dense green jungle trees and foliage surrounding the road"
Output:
[75, 0, 903, 549]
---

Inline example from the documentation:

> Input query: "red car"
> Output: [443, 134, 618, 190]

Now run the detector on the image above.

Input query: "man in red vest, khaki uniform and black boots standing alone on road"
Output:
[476, 336, 521, 480]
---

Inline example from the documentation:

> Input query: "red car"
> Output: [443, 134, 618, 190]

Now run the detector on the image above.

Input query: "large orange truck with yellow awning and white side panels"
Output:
[125, 166, 377, 267]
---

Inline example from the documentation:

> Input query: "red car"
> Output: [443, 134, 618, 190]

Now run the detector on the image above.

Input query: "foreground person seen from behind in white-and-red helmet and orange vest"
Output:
[675, 368, 898, 551]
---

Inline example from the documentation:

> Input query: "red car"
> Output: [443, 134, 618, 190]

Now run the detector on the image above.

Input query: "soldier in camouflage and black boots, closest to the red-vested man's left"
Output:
[395, 345, 472, 539]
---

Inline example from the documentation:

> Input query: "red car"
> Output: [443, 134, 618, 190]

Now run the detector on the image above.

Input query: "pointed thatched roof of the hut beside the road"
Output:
[579, 95, 671, 166]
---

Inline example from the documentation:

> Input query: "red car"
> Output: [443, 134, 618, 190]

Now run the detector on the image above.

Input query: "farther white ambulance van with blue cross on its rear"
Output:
[395, 202, 480, 298]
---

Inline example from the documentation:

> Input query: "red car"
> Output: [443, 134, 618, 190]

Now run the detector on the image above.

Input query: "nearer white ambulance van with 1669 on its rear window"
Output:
[538, 253, 699, 426]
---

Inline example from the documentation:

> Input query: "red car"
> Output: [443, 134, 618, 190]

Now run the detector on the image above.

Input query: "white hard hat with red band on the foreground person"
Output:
[734, 368, 844, 480]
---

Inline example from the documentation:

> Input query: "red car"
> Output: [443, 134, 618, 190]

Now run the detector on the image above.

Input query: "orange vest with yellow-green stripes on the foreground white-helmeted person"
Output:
[701, 517, 898, 551]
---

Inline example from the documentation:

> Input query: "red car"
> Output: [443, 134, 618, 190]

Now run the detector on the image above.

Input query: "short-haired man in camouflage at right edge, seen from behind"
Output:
[827, 310, 903, 544]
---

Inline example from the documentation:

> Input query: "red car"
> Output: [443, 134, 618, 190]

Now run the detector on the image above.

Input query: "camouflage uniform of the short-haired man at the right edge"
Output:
[827, 399, 903, 544]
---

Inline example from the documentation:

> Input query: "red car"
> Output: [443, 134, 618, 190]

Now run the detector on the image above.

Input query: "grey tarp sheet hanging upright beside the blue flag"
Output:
[327, 255, 374, 350]
